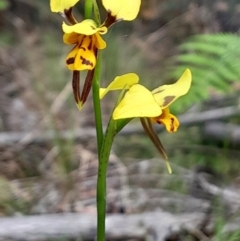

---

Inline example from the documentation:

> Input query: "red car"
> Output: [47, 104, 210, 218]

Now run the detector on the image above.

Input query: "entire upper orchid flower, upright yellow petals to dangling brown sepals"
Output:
[50, 0, 141, 110]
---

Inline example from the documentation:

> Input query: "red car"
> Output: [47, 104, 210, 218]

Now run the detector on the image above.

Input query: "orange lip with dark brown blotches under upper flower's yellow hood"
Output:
[66, 36, 96, 71]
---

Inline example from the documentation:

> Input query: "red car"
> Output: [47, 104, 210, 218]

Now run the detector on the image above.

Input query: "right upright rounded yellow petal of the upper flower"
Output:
[102, 0, 141, 21]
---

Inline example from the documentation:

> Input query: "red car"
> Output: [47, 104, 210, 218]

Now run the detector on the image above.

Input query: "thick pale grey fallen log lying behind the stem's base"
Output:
[0, 212, 205, 241]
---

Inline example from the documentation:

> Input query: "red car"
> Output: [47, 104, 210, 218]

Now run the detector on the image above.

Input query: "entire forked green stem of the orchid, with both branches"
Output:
[85, 0, 111, 241]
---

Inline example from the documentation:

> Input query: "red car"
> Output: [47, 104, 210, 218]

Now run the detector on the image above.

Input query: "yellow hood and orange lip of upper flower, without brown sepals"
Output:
[62, 19, 107, 71]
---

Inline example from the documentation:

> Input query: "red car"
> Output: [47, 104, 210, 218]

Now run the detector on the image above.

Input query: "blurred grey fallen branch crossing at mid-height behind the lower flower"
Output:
[0, 107, 240, 146]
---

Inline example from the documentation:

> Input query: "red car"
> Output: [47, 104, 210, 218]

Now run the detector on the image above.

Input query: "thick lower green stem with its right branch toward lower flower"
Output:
[97, 119, 116, 241]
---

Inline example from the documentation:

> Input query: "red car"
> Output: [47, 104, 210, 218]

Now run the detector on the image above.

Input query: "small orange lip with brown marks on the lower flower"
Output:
[151, 108, 180, 133]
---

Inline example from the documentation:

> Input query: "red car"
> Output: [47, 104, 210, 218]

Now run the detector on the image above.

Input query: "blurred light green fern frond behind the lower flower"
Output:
[168, 33, 240, 109]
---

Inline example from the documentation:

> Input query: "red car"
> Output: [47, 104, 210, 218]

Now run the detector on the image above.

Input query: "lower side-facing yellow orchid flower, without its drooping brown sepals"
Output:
[100, 69, 192, 132]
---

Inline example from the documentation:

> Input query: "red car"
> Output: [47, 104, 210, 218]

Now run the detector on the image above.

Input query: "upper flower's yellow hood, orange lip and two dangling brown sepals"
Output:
[62, 19, 107, 110]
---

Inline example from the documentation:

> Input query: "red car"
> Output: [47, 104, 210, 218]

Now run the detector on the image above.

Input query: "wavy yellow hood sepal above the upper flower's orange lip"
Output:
[62, 19, 107, 35]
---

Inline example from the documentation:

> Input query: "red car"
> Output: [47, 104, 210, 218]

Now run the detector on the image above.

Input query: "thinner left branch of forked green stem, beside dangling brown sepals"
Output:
[92, 53, 103, 156]
